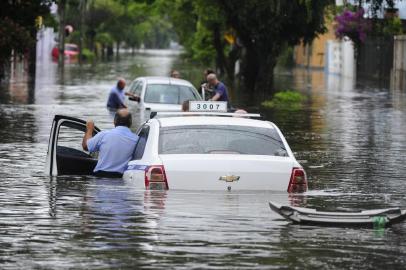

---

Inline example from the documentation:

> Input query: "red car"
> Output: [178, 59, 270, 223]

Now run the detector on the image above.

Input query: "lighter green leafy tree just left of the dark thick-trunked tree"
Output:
[162, 0, 237, 79]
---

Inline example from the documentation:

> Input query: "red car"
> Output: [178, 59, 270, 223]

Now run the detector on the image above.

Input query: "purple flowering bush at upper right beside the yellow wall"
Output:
[335, 8, 370, 44]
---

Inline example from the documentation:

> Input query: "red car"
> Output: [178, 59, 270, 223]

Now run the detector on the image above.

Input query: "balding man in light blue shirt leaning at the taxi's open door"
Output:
[82, 109, 138, 177]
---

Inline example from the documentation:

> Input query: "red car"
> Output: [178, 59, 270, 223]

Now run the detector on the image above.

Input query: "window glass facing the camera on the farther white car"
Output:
[144, 84, 199, 104]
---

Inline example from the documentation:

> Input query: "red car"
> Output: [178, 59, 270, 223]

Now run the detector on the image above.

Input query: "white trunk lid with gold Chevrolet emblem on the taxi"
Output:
[160, 154, 294, 191]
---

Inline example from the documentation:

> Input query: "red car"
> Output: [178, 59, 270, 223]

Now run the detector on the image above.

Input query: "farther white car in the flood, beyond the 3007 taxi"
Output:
[128, 77, 202, 112]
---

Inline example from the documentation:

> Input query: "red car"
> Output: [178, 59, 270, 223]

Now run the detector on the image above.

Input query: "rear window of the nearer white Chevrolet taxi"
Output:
[159, 125, 288, 156]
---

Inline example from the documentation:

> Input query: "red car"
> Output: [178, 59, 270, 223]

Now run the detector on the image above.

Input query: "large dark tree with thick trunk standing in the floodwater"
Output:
[216, 0, 330, 92]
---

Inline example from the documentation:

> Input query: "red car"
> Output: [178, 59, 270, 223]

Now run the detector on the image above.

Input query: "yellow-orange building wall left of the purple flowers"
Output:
[294, 22, 336, 68]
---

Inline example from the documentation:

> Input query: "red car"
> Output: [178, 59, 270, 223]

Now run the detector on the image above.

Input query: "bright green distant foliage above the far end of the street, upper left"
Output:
[63, 0, 176, 54]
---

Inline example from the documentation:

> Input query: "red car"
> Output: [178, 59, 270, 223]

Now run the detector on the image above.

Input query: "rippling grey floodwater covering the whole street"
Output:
[0, 51, 406, 269]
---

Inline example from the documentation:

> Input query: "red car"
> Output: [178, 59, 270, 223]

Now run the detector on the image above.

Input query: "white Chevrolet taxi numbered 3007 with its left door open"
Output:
[46, 106, 307, 192]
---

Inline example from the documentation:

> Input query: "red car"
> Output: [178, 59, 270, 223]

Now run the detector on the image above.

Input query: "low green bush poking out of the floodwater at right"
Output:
[261, 90, 306, 110]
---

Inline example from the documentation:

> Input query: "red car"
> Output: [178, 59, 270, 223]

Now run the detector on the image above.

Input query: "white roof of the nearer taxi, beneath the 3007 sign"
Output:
[152, 116, 273, 128]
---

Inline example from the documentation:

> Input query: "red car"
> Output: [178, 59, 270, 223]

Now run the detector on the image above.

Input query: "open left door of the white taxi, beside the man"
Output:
[45, 115, 100, 176]
